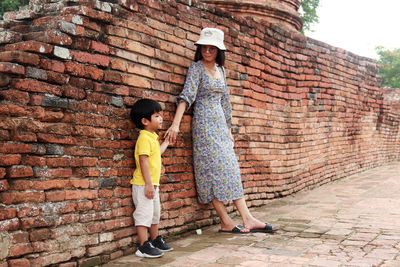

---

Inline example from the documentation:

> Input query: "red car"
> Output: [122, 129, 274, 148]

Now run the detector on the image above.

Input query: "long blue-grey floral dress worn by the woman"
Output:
[178, 61, 244, 204]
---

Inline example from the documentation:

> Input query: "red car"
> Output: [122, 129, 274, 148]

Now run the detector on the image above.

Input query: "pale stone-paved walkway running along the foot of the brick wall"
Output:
[104, 162, 400, 267]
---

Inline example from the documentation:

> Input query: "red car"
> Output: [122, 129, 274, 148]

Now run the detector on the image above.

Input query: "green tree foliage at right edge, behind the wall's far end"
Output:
[376, 46, 400, 88]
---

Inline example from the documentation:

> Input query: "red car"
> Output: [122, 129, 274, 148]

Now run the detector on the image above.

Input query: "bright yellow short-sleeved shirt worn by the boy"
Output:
[131, 130, 161, 186]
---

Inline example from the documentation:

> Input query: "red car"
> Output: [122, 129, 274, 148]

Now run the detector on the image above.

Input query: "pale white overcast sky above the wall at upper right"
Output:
[305, 0, 400, 59]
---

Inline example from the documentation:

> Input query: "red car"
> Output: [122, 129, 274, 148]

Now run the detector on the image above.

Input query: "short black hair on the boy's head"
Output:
[131, 98, 162, 129]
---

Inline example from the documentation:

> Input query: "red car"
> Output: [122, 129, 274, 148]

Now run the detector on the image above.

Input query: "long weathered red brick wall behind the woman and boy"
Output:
[0, 0, 400, 267]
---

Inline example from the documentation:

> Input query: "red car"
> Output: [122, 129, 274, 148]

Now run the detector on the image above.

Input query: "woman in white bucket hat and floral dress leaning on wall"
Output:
[166, 28, 275, 233]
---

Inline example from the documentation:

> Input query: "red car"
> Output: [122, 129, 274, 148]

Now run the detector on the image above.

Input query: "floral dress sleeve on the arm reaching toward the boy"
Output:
[177, 62, 201, 110]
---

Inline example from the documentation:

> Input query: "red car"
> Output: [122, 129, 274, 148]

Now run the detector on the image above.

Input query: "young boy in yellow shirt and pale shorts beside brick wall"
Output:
[131, 99, 173, 258]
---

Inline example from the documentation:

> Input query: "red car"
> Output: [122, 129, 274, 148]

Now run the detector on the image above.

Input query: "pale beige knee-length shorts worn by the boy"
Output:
[132, 185, 161, 227]
